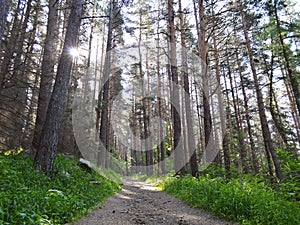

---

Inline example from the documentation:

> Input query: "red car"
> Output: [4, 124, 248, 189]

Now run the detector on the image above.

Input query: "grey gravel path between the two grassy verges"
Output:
[69, 177, 236, 225]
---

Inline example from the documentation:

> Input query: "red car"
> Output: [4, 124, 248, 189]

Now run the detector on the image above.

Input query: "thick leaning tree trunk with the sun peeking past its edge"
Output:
[34, 0, 83, 174]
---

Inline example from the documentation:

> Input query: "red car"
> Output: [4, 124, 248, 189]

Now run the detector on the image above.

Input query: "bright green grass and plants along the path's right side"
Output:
[161, 176, 300, 225]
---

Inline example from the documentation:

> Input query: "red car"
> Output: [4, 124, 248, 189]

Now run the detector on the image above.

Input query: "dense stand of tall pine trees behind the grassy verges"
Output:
[0, 0, 300, 179]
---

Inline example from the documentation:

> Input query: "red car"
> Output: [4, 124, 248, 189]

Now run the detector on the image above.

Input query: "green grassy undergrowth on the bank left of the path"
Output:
[0, 152, 120, 225]
